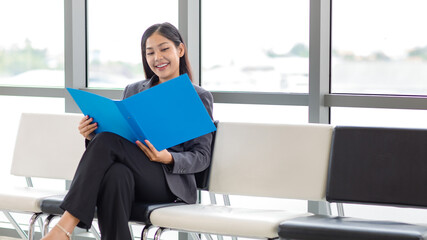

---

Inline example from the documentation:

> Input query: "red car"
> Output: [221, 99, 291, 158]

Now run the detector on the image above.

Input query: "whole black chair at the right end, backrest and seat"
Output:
[279, 126, 427, 240]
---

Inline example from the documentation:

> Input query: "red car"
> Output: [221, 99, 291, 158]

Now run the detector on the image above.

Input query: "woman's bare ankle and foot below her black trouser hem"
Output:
[42, 211, 79, 240]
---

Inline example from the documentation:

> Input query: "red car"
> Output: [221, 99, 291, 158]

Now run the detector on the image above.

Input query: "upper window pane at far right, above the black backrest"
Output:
[331, 0, 427, 95]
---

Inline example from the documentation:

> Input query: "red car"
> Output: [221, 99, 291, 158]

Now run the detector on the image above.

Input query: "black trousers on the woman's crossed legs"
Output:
[61, 132, 176, 240]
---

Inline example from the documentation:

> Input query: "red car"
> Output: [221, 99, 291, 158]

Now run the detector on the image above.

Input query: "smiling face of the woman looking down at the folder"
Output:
[145, 32, 184, 83]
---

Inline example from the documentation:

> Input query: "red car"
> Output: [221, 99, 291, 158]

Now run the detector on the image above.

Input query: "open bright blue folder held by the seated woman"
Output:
[67, 74, 216, 151]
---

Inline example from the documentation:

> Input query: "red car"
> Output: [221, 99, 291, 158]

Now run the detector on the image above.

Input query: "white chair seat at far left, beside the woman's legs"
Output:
[0, 187, 66, 213]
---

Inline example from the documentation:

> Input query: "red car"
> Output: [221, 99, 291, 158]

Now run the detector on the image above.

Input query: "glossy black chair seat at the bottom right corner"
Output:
[279, 216, 427, 240]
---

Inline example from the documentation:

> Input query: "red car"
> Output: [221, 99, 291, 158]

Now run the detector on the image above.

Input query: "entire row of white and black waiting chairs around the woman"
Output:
[0, 114, 427, 240]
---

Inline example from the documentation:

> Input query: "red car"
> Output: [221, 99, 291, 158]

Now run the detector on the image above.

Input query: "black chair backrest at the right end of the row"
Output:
[327, 126, 427, 207]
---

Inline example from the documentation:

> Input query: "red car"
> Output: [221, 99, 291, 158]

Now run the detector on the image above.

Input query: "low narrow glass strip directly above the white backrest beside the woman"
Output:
[213, 103, 308, 124]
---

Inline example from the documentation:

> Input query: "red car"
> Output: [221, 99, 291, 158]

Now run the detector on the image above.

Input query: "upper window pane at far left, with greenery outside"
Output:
[0, 0, 64, 87]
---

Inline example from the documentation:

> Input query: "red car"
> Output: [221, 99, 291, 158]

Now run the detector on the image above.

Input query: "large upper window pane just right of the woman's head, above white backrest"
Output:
[201, 0, 309, 93]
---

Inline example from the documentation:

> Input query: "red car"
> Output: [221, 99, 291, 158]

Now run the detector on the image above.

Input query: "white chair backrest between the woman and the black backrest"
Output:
[209, 122, 333, 200]
